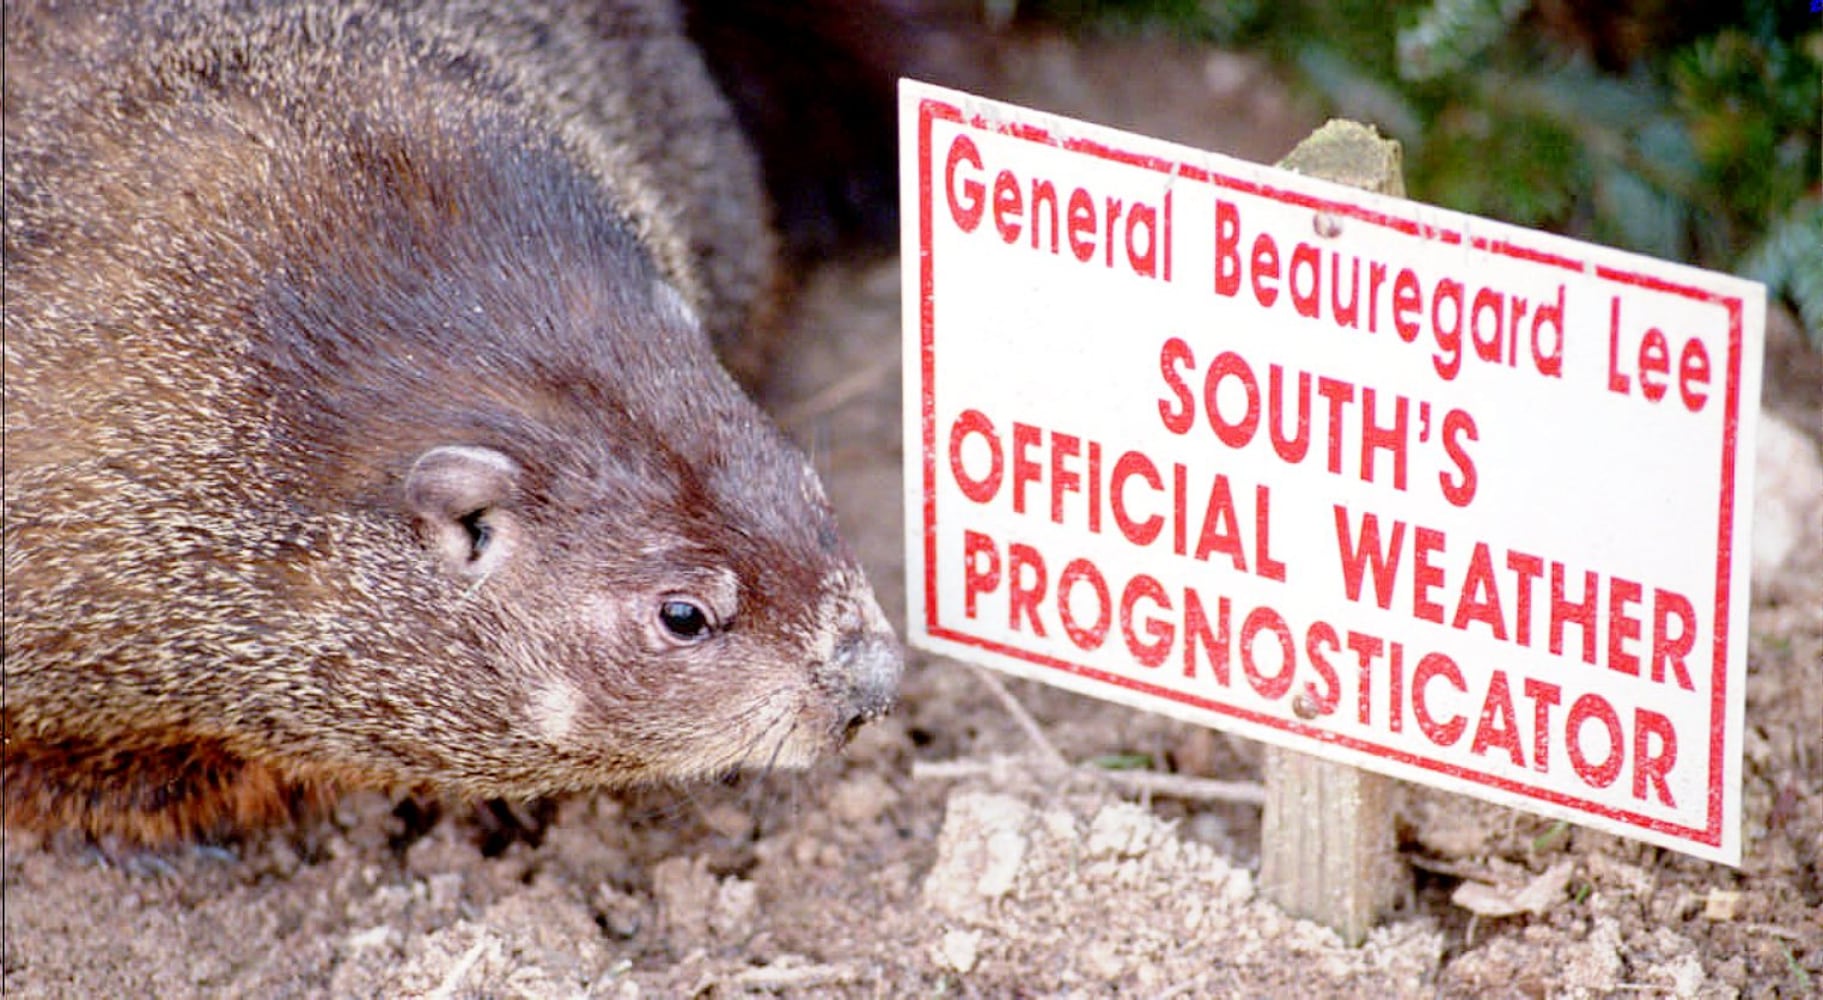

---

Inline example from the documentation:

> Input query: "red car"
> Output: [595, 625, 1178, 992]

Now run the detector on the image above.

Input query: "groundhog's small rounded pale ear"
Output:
[405, 444, 520, 577]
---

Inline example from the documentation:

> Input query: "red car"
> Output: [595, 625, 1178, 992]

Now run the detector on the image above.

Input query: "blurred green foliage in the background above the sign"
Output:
[1028, 0, 1823, 348]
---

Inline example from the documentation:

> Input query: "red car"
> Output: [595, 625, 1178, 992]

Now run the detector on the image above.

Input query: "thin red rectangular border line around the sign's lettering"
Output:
[917, 98, 1745, 847]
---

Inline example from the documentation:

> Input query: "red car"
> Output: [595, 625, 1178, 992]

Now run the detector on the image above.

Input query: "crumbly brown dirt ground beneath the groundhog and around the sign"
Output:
[4, 27, 1823, 998]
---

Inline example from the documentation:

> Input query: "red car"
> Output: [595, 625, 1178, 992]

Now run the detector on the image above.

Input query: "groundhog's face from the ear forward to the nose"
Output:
[399, 284, 901, 783]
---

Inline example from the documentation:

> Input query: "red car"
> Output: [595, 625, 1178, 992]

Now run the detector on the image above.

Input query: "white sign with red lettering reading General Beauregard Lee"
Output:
[901, 82, 1765, 863]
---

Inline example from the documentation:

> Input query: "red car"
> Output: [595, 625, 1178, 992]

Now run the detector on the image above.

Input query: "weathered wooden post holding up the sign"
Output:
[1260, 118, 1407, 945]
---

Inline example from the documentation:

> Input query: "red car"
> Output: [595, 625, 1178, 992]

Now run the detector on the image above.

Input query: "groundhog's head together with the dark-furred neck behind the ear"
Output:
[259, 105, 901, 794]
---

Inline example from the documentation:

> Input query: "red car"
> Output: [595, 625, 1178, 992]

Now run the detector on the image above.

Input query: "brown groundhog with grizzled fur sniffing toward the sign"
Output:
[4, 0, 901, 843]
